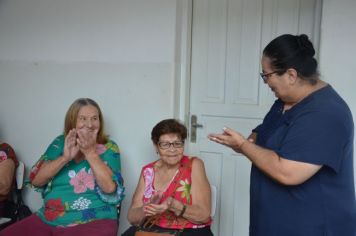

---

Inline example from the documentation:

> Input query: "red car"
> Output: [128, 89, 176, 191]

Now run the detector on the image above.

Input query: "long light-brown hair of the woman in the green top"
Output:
[64, 98, 108, 144]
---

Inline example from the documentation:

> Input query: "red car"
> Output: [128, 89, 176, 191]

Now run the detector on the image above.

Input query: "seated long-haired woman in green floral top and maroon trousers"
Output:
[0, 98, 124, 236]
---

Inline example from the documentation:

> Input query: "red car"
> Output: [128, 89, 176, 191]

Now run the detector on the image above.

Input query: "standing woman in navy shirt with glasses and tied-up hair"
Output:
[209, 34, 356, 236]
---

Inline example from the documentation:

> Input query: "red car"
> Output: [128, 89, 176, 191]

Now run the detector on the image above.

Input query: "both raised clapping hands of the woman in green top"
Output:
[63, 128, 98, 161]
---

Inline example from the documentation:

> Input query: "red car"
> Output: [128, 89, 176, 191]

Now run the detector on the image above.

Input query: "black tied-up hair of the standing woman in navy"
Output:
[263, 34, 319, 84]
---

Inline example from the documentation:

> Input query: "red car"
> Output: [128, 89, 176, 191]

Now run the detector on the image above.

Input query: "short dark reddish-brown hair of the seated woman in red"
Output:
[151, 119, 187, 144]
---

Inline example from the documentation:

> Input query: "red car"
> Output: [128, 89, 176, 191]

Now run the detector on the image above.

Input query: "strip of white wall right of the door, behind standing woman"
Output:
[320, 0, 356, 183]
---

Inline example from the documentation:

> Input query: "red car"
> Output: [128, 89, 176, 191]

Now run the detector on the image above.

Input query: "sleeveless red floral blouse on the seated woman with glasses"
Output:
[141, 156, 212, 229]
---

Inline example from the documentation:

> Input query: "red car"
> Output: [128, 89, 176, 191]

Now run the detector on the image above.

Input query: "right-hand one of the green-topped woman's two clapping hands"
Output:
[77, 128, 98, 156]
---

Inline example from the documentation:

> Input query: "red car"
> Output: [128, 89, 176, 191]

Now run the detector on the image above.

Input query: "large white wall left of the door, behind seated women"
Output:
[0, 0, 176, 231]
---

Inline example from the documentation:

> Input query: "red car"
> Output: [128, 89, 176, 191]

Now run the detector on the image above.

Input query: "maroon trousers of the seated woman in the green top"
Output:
[0, 214, 118, 236]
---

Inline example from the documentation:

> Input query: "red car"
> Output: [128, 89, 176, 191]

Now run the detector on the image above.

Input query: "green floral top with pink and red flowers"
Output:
[27, 135, 124, 227]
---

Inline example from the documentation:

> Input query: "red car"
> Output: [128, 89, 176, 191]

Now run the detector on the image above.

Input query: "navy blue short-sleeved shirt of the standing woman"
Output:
[250, 85, 356, 236]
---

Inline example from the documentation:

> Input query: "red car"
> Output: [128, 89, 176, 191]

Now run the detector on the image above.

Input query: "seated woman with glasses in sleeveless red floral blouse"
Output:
[123, 119, 213, 236]
